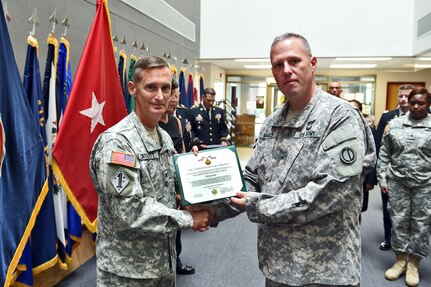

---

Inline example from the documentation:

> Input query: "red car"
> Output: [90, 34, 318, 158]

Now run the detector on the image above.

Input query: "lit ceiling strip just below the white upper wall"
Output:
[199, 57, 431, 74]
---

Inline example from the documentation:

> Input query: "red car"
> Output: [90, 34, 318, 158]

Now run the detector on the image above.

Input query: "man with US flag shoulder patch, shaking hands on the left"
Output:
[90, 57, 208, 287]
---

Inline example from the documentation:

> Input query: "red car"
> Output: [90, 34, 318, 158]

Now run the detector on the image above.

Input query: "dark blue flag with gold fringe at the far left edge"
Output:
[0, 0, 47, 286]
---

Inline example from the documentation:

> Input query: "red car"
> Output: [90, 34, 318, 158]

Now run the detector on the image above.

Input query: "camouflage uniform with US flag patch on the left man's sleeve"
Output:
[90, 112, 193, 286]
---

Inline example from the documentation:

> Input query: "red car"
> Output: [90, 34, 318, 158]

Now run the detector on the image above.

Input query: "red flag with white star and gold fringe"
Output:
[53, 0, 127, 232]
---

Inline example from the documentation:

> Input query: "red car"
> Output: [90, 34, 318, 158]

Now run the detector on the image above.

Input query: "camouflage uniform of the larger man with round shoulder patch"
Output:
[216, 88, 376, 286]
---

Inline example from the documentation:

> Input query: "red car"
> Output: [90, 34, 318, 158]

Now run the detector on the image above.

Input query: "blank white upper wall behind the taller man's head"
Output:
[200, 0, 416, 59]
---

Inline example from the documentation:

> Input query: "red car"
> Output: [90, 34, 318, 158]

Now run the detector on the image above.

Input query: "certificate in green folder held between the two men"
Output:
[174, 146, 246, 206]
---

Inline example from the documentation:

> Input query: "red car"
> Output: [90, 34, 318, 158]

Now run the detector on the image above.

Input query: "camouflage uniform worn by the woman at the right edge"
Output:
[377, 114, 431, 258]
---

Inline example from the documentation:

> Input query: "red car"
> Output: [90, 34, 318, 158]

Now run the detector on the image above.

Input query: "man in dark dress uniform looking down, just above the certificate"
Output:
[190, 88, 228, 149]
